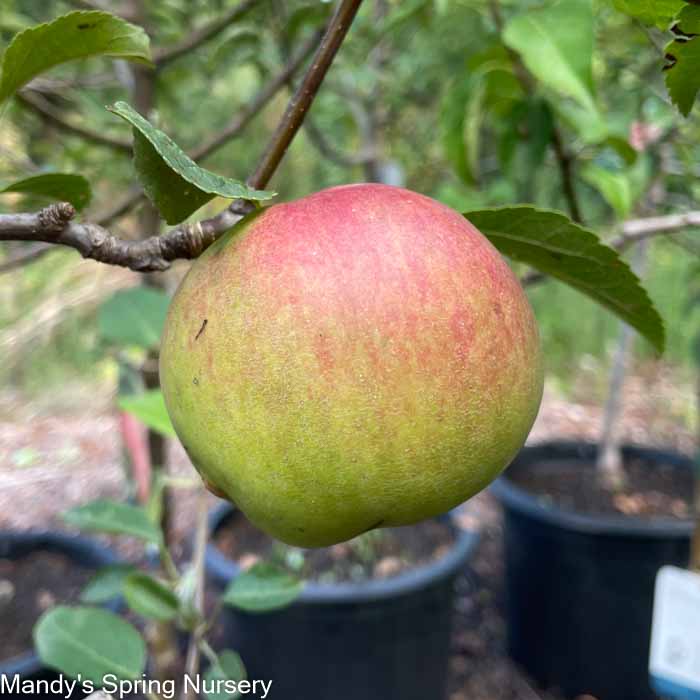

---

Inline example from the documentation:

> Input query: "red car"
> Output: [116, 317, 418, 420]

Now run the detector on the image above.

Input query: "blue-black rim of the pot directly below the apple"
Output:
[206, 503, 479, 605]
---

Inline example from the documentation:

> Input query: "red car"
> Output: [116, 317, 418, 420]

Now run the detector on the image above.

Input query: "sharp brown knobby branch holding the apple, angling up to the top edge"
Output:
[0, 0, 362, 272]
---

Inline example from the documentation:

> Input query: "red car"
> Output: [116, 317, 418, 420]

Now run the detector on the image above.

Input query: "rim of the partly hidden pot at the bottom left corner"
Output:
[0, 530, 121, 678]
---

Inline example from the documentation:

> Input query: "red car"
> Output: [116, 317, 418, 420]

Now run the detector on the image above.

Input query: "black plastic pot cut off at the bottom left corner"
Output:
[0, 531, 119, 700]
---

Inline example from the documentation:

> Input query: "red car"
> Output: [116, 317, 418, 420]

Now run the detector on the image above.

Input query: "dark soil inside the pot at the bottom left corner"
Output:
[0, 551, 94, 661]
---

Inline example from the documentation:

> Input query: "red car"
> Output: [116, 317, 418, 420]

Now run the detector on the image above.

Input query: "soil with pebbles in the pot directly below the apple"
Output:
[214, 513, 455, 583]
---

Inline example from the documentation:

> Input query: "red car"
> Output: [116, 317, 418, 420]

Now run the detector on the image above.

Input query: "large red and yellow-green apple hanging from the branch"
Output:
[160, 184, 542, 547]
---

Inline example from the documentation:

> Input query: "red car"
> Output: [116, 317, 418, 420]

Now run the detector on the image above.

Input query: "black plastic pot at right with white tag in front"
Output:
[491, 442, 693, 700]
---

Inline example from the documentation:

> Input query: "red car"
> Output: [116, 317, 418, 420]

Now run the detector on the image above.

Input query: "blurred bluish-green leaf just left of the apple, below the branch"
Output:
[97, 285, 170, 350]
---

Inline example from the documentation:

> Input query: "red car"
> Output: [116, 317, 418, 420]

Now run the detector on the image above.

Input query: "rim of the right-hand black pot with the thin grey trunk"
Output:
[489, 440, 695, 539]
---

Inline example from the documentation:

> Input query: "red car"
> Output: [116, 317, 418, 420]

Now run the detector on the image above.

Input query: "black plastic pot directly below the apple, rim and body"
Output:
[206, 505, 478, 700]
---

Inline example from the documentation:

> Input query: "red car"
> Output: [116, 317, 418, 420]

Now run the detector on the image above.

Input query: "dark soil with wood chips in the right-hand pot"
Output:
[508, 459, 694, 520]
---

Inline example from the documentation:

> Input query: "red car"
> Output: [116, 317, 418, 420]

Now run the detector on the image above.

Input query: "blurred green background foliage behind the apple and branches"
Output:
[0, 0, 700, 394]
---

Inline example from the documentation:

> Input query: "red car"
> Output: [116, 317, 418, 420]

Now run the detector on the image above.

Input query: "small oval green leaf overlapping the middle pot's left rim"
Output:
[223, 563, 303, 612]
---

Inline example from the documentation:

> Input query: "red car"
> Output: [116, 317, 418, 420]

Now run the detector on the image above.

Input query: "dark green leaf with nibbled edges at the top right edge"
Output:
[665, 5, 700, 117]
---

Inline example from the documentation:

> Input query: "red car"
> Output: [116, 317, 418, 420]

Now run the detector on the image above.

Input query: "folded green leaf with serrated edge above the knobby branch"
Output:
[108, 102, 275, 224]
